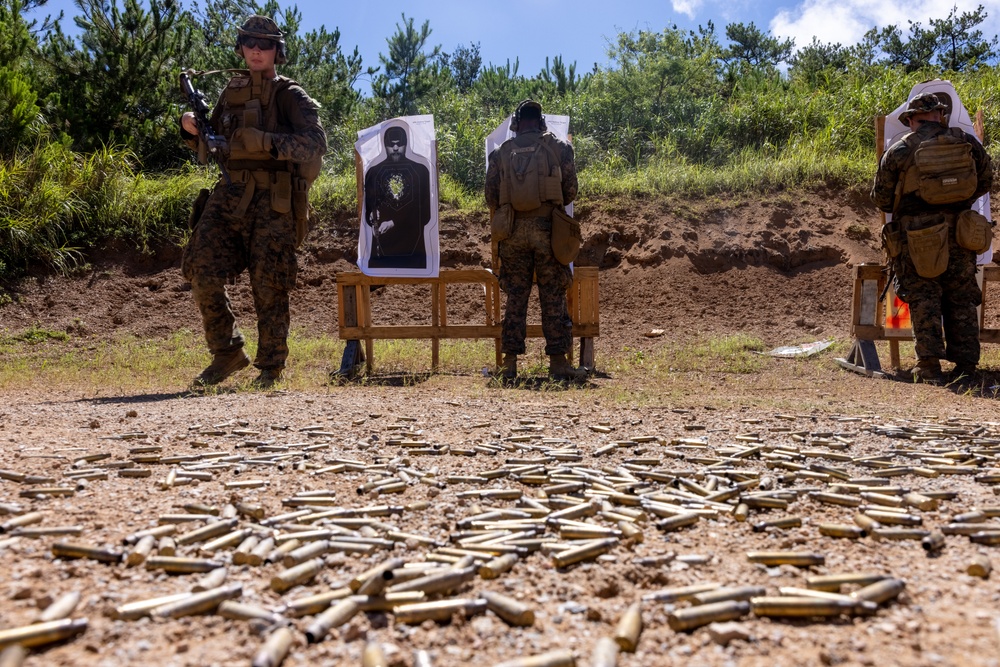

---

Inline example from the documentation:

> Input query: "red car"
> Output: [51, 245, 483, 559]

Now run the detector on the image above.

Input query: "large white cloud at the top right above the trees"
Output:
[769, 0, 1000, 47]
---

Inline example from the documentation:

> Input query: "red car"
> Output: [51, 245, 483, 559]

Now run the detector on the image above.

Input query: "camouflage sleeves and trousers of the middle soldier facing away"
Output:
[485, 131, 579, 355]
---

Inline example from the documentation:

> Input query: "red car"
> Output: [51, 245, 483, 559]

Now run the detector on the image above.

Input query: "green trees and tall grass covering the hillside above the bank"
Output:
[0, 0, 1000, 279]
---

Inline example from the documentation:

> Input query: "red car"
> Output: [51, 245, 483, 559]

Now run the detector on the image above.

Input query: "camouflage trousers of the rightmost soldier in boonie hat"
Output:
[893, 232, 983, 366]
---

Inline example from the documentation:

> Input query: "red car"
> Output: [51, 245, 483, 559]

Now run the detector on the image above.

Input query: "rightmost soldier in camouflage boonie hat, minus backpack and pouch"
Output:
[871, 93, 993, 382]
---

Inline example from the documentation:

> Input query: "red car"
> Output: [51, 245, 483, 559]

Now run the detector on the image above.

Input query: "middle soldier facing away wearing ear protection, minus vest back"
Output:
[485, 100, 586, 380]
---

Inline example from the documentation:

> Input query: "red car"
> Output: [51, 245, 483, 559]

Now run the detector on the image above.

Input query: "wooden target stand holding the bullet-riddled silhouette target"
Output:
[334, 151, 600, 378]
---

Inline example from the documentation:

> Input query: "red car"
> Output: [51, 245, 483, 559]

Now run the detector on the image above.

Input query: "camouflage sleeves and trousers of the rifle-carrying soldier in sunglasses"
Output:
[181, 77, 326, 370]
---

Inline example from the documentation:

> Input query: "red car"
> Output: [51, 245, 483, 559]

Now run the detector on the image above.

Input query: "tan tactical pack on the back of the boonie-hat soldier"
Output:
[900, 127, 977, 206]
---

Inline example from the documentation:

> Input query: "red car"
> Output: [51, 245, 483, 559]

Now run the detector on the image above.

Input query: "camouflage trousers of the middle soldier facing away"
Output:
[499, 218, 573, 355]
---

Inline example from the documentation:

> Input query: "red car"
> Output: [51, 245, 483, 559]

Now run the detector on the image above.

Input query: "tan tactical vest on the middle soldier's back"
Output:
[500, 132, 563, 212]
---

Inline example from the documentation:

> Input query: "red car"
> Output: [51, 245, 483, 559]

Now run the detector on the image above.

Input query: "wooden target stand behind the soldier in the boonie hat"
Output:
[836, 111, 1000, 377]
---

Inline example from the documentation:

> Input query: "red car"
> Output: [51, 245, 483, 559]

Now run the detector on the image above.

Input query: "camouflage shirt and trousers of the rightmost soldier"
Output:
[871, 123, 993, 366]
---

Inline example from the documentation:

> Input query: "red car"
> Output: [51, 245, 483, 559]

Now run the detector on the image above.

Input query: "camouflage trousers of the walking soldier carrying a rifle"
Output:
[181, 183, 298, 369]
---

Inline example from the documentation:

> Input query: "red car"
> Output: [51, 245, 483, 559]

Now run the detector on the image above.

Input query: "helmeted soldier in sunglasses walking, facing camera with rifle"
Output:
[181, 16, 327, 387]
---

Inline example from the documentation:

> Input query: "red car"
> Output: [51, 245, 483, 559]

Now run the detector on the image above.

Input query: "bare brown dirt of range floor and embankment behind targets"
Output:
[0, 192, 1000, 667]
